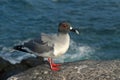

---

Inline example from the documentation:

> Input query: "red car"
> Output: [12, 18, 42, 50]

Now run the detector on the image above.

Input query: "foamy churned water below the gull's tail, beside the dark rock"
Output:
[0, 47, 36, 64]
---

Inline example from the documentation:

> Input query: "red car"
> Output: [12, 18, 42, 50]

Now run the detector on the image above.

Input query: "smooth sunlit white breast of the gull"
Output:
[54, 34, 70, 56]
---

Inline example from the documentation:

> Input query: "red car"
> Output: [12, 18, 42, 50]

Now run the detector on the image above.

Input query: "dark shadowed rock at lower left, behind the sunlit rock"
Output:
[0, 57, 45, 80]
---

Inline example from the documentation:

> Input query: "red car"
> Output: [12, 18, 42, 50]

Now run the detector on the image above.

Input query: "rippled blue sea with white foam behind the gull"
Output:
[0, 0, 120, 63]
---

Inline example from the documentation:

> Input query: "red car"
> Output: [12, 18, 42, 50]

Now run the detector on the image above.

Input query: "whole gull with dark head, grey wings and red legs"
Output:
[14, 21, 79, 71]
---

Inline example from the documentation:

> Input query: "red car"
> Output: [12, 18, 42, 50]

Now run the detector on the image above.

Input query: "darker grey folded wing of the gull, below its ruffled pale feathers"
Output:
[23, 39, 54, 53]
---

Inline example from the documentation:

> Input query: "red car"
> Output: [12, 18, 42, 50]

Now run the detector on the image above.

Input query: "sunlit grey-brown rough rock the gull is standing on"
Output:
[7, 60, 120, 80]
